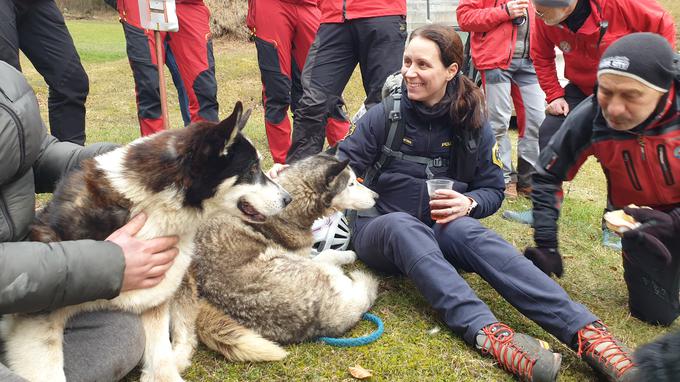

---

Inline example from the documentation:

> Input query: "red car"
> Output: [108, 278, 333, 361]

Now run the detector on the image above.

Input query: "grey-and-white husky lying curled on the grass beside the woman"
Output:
[192, 154, 378, 361]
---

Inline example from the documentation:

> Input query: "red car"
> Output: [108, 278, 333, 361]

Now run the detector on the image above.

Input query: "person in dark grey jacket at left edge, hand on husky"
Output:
[0, 62, 178, 382]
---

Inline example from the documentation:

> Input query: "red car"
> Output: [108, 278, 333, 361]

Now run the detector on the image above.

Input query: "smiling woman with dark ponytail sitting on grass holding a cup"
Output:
[338, 24, 636, 381]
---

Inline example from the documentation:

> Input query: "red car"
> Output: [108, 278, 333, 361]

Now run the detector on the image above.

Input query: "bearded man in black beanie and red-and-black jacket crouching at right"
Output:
[525, 33, 680, 324]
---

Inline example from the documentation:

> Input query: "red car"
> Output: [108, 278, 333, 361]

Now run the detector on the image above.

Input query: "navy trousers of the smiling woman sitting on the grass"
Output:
[352, 212, 598, 347]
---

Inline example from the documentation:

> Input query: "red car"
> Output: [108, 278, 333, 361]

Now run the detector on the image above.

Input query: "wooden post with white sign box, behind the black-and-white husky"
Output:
[139, 0, 179, 130]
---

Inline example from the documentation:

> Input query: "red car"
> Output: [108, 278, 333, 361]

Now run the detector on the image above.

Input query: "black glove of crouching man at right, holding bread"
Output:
[622, 207, 680, 264]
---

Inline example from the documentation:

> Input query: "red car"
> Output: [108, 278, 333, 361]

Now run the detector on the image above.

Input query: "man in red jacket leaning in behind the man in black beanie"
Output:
[503, 0, 675, 249]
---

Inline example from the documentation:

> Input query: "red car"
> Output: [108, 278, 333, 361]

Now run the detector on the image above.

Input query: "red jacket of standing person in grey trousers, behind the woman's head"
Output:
[456, 0, 535, 70]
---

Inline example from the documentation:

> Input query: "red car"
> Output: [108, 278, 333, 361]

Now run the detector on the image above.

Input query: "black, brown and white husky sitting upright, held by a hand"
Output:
[2, 102, 290, 382]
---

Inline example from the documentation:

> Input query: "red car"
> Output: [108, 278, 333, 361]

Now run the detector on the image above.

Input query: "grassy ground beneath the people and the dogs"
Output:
[23, 5, 680, 381]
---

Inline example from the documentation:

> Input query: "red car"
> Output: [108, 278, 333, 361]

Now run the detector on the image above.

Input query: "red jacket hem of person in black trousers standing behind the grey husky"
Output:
[318, 0, 406, 23]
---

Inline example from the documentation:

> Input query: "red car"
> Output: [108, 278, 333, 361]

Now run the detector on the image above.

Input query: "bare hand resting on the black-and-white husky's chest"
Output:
[106, 213, 179, 292]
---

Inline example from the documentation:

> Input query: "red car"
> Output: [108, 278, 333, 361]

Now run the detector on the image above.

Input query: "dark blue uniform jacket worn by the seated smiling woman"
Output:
[338, 95, 505, 225]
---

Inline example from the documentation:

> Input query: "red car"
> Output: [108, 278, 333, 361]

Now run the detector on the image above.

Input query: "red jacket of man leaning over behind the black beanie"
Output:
[531, 0, 675, 102]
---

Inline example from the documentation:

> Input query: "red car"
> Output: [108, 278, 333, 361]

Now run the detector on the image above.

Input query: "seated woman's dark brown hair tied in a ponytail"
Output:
[408, 24, 485, 130]
